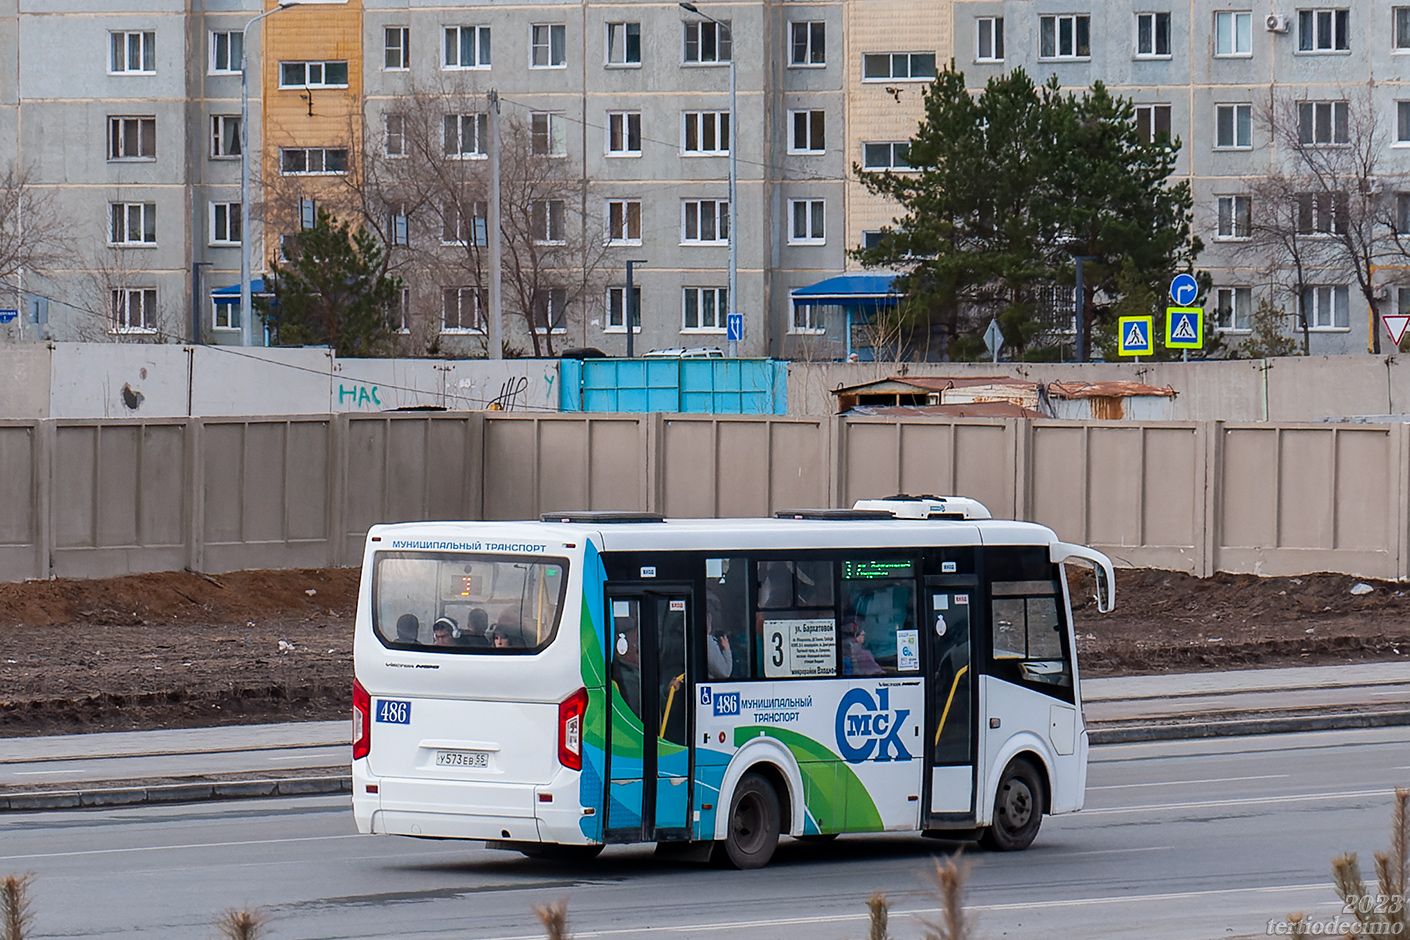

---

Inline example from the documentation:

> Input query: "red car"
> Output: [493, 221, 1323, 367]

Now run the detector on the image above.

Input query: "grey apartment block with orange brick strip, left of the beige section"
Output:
[0, 0, 857, 355]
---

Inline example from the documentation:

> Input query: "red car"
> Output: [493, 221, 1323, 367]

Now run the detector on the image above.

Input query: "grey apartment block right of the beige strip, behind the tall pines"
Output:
[955, 0, 1410, 355]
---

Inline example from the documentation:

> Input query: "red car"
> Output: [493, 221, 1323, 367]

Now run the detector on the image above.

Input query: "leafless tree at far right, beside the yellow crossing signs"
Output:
[1261, 86, 1397, 352]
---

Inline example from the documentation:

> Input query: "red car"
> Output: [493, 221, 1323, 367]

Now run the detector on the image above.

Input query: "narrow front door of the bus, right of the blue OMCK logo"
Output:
[922, 575, 979, 829]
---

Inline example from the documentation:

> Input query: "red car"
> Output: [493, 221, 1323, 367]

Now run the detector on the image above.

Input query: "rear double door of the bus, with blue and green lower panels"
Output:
[606, 586, 691, 841]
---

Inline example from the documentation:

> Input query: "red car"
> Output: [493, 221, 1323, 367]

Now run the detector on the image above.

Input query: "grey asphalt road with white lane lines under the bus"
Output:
[0, 729, 1410, 940]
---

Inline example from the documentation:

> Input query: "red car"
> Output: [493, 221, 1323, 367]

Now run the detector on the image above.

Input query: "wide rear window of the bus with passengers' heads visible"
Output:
[372, 552, 568, 655]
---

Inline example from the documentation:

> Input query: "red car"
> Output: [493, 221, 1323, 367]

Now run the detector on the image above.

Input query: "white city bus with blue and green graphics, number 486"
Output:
[353, 496, 1114, 868]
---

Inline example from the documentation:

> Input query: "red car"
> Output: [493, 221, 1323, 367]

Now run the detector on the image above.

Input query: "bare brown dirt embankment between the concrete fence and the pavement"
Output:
[0, 568, 1410, 736]
